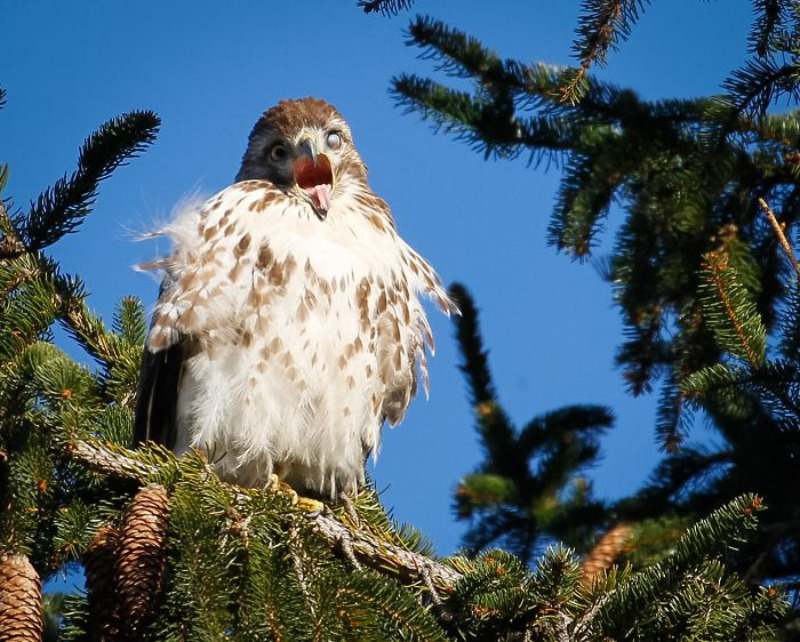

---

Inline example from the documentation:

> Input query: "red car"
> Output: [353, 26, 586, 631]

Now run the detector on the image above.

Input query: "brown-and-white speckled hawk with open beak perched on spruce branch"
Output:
[135, 98, 457, 496]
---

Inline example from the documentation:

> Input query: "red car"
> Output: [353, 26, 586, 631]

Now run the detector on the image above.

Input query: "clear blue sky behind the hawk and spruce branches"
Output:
[0, 0, 752, 554]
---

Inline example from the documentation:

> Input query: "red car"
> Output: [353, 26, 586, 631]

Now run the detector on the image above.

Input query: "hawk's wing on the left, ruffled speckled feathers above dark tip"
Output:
[134, 181, 281, 448]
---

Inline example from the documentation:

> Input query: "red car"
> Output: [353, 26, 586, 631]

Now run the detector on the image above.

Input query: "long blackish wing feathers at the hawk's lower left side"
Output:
[133, 341, 184, 449]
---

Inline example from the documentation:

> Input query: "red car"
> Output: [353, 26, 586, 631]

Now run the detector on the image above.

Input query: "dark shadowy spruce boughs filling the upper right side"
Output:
[360, 0, 800, 630]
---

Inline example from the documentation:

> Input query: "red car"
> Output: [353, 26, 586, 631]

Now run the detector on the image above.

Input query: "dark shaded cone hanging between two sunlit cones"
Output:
[83, 525, 121, 640]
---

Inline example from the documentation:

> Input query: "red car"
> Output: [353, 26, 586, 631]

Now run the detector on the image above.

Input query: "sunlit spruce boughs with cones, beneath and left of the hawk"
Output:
[0, 81, 786, 642]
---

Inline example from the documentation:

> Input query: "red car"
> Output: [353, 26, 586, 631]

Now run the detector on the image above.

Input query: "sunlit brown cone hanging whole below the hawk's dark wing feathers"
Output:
[117, 484, 169, 633]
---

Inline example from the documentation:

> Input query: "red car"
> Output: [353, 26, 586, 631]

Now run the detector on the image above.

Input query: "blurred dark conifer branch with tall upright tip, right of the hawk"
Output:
[450, 283, 614, 562]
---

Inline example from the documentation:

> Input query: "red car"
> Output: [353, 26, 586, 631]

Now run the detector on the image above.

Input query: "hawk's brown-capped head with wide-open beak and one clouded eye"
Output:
[236, 98, 366, 220]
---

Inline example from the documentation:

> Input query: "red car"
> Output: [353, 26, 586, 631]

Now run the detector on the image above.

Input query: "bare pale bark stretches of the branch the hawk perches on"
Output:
[67, 439, 461, 592]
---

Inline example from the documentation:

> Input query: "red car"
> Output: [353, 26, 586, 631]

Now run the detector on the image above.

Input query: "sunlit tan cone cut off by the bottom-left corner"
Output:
[0, 555, 42, 642]
